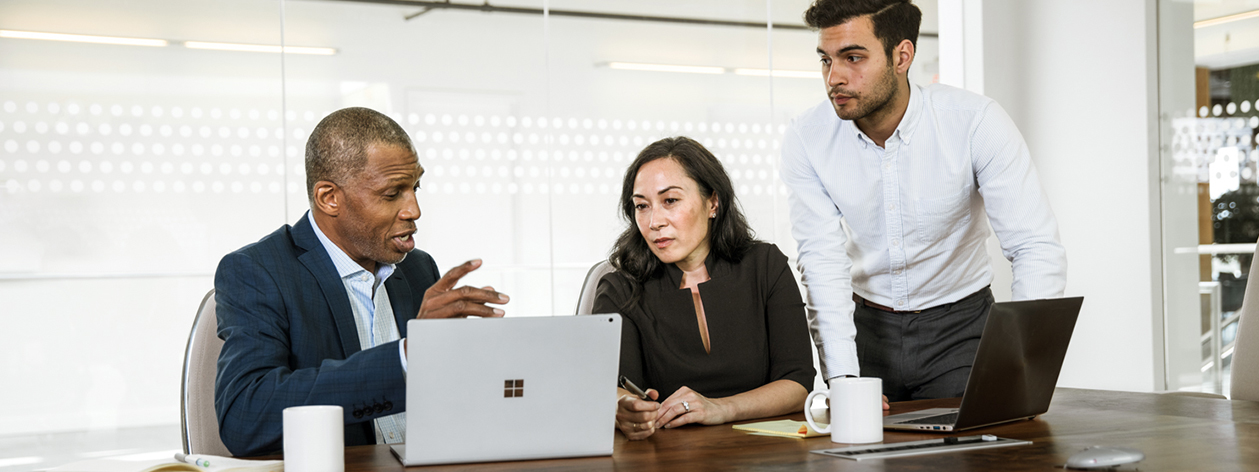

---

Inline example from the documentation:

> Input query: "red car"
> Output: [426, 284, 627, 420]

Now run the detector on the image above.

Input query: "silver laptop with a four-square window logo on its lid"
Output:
[392, 315, 621, 466]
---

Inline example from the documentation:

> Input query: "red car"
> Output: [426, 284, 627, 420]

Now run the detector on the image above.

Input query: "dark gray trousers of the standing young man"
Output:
[852, 287, 993, 402]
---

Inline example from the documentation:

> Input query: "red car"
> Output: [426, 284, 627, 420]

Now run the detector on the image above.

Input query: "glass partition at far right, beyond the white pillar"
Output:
[1158, 0, 1259, 394]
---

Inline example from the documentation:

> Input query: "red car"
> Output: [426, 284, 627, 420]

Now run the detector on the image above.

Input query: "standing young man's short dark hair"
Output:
[805, 0, 923, 58]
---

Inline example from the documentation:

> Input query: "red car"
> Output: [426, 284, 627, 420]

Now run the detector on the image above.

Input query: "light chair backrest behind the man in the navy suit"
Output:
[179, 289, 232, 457]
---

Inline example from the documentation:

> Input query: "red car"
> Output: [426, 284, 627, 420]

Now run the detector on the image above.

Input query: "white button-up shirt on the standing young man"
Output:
[782, 84, 1066, 379]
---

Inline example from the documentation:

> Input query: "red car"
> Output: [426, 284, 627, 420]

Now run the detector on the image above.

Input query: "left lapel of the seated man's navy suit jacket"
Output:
[293, 214, 367, 357]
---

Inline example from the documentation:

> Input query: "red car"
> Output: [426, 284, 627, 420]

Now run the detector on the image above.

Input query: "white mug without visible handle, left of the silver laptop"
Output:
[285, 405, 345, 472]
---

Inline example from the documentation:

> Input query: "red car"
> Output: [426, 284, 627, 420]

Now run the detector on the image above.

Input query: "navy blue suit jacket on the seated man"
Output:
[214, 215, 441, 456]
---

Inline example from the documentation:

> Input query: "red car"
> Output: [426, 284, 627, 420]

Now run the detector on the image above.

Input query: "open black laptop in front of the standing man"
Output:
[883, 297, 1084, 430]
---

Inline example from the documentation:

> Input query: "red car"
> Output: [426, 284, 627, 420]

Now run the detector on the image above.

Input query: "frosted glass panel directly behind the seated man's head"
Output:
[285, 1, 551, 316]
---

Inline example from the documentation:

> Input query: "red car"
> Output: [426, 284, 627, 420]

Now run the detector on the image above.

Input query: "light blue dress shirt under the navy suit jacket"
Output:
[306, 211, 407, 444]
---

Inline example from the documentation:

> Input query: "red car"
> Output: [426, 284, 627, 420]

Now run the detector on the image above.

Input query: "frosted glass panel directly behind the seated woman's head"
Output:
[548, 0, 777, 312]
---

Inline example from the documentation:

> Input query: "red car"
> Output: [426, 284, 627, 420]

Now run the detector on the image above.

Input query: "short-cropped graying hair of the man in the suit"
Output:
[306, 107, 415, 204]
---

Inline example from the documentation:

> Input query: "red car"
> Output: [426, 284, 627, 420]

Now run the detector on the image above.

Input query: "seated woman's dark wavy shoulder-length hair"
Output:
[608, 136, 755, 307]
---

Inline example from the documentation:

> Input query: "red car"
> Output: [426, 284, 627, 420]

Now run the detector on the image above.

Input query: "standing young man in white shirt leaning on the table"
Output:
[782, 0, 1066, 402]
